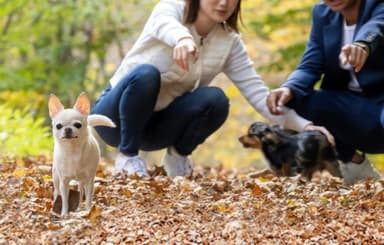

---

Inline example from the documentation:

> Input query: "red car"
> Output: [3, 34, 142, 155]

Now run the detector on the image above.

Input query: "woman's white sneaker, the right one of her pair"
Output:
[161, 147, 192, 177]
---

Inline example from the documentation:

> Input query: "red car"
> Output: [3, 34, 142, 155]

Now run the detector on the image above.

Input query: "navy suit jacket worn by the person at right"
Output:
[282, 0, 384, 99]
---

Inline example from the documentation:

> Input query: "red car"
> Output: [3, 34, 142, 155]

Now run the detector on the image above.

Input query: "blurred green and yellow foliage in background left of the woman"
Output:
[0, 0, 155, 159]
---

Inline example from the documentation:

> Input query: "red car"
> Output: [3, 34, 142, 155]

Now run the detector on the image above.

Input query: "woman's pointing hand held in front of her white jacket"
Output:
[173, 37, 199, 71]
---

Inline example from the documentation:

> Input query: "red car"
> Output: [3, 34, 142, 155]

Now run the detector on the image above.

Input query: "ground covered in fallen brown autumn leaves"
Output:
[0, 158, 384, 244]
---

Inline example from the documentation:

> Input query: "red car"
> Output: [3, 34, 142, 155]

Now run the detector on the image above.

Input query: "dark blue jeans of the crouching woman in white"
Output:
[92, 65, 229, 155]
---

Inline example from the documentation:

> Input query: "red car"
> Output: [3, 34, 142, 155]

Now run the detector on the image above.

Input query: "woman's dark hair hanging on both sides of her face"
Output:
[184, 0, 242, 32]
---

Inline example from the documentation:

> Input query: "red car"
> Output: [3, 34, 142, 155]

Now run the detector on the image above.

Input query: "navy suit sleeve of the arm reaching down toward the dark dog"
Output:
[282, 5, 324, 100]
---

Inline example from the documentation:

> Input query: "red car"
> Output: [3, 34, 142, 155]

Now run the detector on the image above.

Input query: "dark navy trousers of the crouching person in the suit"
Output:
[290, 89, 384, 162]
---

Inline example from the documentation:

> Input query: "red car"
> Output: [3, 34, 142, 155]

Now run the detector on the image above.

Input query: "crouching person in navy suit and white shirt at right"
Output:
[267, 0, 384, 184]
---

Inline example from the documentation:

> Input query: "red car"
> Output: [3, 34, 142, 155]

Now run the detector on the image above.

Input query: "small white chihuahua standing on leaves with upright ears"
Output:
[48, 93, 116, 215]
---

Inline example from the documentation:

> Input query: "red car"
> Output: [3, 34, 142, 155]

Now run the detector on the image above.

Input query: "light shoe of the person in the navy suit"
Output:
[340, 158, 381, 185]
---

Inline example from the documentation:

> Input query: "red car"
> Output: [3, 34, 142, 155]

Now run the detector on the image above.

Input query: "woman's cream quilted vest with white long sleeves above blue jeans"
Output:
[110, 0, 310, 131]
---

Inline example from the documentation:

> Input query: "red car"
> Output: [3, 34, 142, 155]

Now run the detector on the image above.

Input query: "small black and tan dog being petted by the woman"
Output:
[239, 122, 341, 180]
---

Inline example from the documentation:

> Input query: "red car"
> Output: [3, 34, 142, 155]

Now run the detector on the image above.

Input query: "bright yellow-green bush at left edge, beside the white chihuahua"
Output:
[0, 104, 53, 157]
